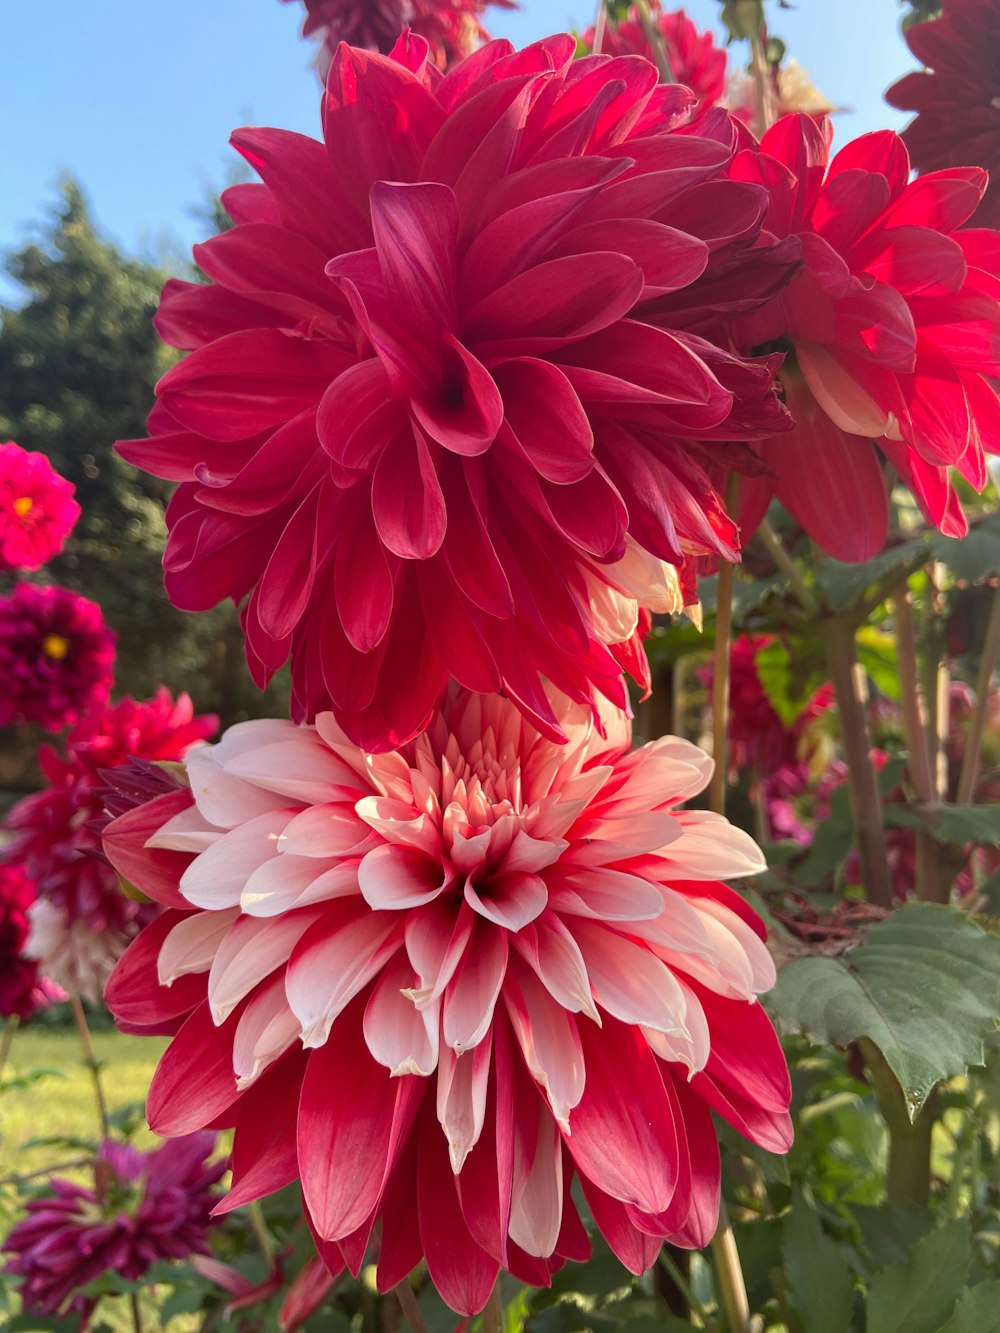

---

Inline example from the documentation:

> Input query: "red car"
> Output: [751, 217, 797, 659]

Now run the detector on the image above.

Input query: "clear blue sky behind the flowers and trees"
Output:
[0, 0, 913, 299]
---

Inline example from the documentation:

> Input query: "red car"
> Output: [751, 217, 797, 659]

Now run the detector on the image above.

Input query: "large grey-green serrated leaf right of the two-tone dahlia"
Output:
[765, 902, 1000, 1120]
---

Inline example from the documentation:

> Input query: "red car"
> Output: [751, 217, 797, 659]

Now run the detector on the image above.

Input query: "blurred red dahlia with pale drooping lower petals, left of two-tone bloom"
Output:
[3, 689, 219, 998]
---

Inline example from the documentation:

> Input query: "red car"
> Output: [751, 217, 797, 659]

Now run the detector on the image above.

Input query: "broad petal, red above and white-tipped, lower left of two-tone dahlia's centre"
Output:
[285, 905, 403, 1048]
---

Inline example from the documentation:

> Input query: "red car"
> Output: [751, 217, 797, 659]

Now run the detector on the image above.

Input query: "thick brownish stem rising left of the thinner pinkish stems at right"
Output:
[821, 616, 892, 908]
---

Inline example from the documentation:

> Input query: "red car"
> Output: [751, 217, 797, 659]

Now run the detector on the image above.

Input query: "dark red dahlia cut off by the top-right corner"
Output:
[885, 0, 1000, 227]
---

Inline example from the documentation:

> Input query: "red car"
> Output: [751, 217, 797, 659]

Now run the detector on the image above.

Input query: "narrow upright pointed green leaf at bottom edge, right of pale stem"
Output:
[781, 1194, 855, 1333]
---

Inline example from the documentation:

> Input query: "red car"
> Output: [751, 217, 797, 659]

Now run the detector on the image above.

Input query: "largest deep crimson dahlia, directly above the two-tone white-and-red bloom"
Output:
[119, 37, 797, 749]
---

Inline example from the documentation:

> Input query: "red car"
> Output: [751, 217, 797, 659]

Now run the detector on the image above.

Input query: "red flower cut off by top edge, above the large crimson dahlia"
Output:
[285, 0, 516, 79]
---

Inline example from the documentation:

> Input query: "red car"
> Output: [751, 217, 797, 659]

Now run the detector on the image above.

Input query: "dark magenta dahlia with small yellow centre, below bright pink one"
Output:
[0, 583, 116, 732]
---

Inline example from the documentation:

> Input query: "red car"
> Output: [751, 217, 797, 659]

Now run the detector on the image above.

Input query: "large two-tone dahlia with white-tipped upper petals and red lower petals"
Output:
[104, 692, 791, 1314]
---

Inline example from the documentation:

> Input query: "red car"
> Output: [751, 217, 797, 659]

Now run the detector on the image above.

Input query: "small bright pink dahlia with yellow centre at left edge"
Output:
[0, 440, 80, 573]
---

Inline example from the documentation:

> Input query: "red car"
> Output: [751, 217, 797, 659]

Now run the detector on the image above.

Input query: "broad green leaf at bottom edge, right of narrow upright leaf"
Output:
[868, 1217, 981, 1333]
